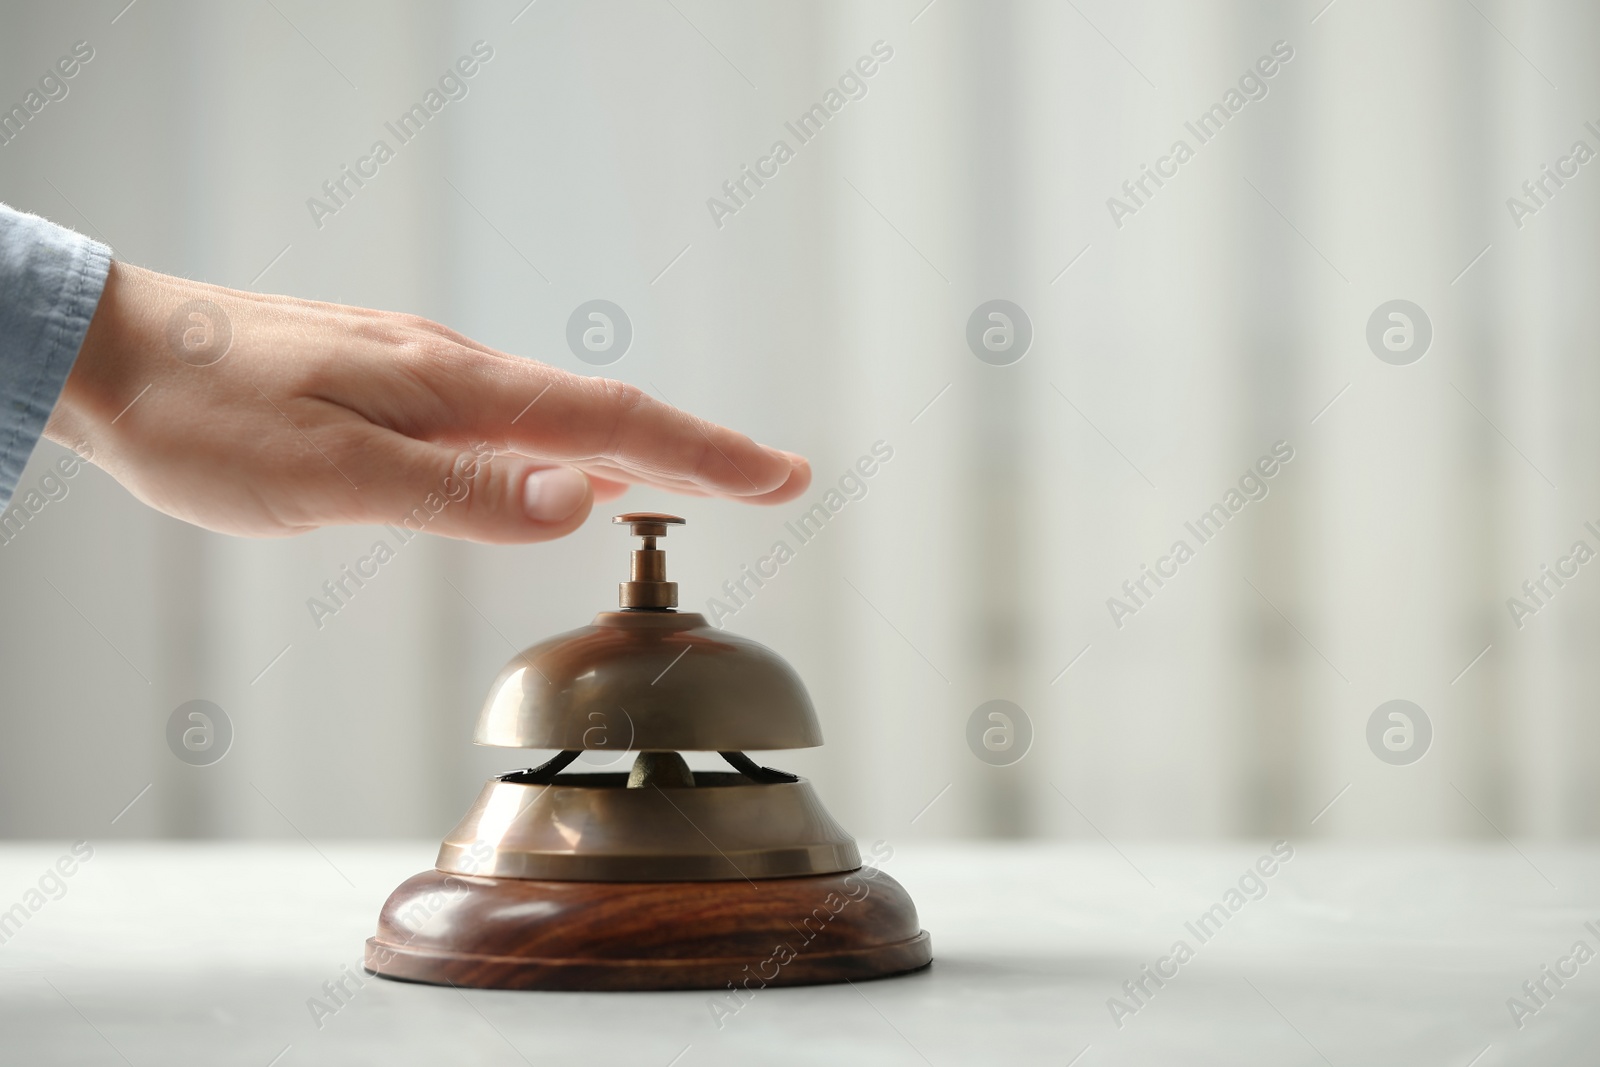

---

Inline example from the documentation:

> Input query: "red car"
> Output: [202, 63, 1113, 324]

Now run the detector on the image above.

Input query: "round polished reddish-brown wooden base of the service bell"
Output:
[366, 867, 933, 990]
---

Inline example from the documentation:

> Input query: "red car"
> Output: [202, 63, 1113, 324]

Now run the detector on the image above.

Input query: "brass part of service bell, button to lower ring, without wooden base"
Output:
[438, 512, 861, 881]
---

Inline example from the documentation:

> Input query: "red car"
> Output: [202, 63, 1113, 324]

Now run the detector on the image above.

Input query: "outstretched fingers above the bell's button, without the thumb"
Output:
[388, 347, 810, 502]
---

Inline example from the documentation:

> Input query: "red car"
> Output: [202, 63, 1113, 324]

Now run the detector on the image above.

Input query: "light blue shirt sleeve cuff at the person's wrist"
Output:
[0, 203, 110, 510]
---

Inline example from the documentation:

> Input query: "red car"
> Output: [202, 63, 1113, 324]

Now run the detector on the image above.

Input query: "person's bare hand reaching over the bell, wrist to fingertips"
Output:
[45, 262, 811, 542]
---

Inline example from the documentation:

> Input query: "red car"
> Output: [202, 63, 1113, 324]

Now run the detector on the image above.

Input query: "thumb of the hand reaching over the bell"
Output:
[342, 430, 594, 544]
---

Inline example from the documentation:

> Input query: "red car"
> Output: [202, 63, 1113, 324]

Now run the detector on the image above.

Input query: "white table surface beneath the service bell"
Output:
[0, 841, 1600, 1067]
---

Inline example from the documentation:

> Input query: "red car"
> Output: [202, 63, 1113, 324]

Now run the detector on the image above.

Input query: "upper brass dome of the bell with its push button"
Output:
[474, 512, 822, 752]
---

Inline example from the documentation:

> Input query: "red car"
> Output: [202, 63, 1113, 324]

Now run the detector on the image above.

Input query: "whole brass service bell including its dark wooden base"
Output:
[366, 514, 933, 989]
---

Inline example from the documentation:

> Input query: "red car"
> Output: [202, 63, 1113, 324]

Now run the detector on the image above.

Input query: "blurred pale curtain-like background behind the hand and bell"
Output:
[0, 0, 1600, 843]
